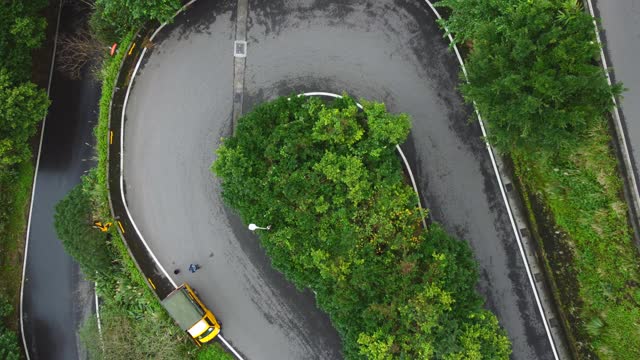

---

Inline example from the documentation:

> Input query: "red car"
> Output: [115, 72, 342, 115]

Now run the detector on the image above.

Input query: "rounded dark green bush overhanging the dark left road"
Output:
[54, 180, 114, 279]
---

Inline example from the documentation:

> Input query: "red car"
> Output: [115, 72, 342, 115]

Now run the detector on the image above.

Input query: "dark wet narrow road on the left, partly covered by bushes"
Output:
[23, 3, 100, 360]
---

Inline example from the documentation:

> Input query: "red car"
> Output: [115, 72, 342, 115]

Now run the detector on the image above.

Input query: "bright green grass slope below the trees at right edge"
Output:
[512, 121, 640, 359]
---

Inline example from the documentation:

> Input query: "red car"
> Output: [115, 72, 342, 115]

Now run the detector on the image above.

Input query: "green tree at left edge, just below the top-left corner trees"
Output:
[0, 69, 49, 171]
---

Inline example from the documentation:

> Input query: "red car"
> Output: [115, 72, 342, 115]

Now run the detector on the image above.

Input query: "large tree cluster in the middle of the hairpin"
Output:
[213, 97, 511, 359]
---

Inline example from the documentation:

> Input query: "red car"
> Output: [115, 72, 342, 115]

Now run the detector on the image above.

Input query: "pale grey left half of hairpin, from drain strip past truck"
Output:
[124, 1, 340, 359]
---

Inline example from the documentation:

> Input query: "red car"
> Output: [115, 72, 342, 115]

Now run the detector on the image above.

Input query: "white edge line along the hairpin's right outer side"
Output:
[425, 0, 559, 360]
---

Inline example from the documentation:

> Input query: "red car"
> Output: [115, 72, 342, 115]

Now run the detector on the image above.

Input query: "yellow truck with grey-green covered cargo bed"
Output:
[162, 283, 220, 345]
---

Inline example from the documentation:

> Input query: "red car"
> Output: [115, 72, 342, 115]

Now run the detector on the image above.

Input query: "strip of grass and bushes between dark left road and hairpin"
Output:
[54, 0, 233, 360]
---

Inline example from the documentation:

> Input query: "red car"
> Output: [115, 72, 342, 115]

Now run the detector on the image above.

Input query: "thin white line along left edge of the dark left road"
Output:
[19, 0, 64, 360]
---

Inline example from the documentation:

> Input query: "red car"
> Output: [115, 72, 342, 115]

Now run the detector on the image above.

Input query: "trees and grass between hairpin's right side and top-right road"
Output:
[438, 0, 640, 359]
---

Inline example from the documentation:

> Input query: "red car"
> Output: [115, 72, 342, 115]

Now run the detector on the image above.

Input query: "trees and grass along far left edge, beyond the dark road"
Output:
[0, 0, 49, 359]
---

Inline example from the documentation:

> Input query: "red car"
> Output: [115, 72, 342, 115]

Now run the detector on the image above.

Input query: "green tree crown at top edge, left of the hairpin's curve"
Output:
[90, 0, 182, 42]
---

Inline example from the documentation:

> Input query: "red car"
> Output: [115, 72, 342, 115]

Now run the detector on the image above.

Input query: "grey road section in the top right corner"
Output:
[593, 0, 640, 197]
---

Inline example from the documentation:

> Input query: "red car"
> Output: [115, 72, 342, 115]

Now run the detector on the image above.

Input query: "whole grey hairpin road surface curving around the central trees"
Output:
[124, 0, 552, 359]
